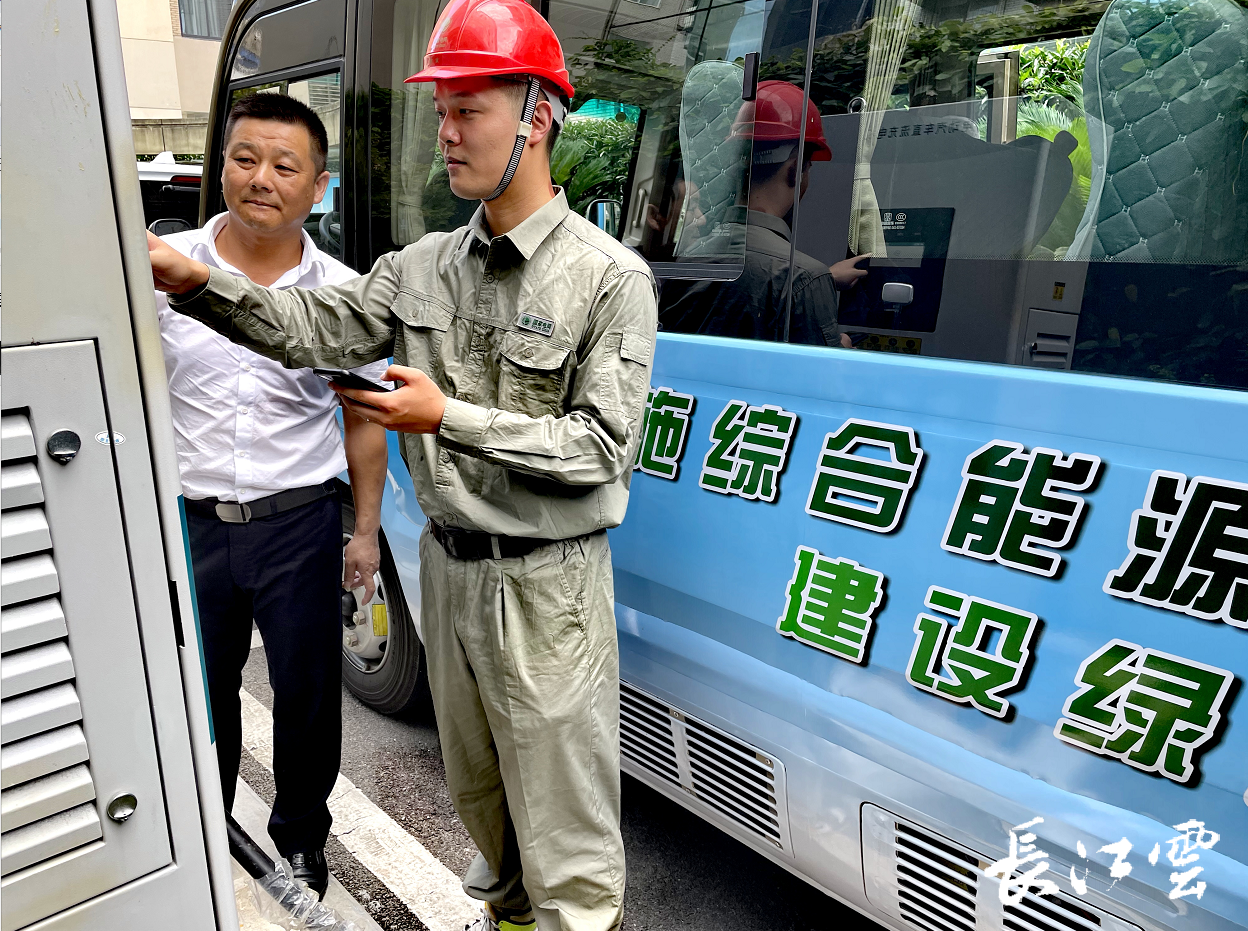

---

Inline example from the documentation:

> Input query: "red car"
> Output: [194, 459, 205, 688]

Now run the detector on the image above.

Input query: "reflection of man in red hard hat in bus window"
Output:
[661, 81, 866, 346]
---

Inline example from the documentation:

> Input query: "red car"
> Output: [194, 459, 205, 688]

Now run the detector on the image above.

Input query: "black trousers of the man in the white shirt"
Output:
[186, 495, 342, 856]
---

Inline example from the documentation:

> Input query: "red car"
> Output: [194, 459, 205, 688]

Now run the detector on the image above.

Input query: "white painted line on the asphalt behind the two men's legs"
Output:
[240, 689, 480, 931]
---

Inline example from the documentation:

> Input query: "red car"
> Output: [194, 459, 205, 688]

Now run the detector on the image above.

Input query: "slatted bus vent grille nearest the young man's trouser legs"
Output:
[620, 681, 791, 852]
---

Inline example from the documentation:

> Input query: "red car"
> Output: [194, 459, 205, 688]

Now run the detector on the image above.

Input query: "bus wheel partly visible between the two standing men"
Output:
[342, 486, 429, 714]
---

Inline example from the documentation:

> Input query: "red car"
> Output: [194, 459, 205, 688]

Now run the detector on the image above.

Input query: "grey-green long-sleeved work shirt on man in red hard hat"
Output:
[170, 191, 658, 539]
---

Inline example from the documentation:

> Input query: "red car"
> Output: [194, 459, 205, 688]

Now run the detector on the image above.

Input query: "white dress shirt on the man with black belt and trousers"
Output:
[156, 213, 388, 503]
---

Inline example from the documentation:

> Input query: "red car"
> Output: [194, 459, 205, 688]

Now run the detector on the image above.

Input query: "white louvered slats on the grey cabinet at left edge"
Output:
[0, 413, 102, 876]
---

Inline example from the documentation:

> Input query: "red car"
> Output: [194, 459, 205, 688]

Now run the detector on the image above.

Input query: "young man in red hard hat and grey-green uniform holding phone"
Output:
[151, 0, 656, 931]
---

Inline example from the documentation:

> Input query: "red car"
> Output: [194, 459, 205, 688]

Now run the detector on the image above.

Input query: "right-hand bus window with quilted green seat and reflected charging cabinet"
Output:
[797, 0, 1248, 387]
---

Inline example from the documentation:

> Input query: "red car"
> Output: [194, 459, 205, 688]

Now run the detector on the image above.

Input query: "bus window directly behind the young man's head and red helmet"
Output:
[371, 0, 763, 277]
